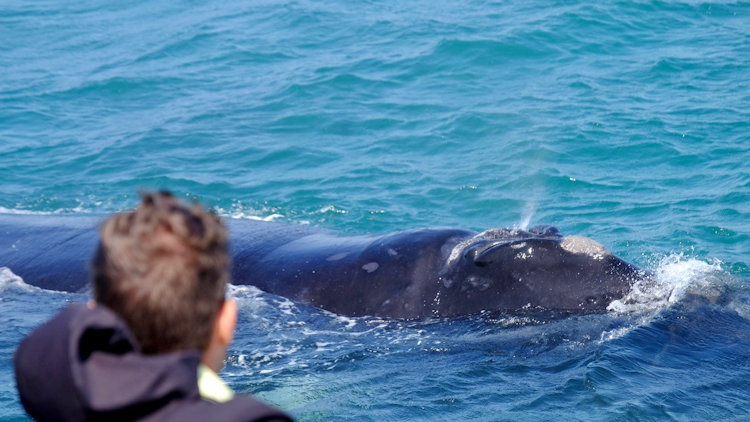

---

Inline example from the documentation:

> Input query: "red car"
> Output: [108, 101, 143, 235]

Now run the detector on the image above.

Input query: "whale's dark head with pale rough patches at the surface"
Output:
[437, 226, 643, 315]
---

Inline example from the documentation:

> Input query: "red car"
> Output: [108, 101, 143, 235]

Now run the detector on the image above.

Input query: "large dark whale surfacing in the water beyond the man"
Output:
[0, 214, 649, 319]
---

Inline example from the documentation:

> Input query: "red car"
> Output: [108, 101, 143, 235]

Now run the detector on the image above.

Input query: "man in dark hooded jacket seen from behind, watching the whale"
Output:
[14, 192, 291, 421]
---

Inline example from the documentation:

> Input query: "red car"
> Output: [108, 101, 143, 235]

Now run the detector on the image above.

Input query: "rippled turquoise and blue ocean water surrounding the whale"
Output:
[0, 0, 750, 421]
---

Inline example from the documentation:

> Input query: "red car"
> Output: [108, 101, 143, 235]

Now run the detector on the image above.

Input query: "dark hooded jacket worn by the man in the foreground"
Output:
[14, 305, 291, 422]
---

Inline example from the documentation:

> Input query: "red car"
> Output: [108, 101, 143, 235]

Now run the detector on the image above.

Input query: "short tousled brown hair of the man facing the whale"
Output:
[92, 191, 229, 354]
